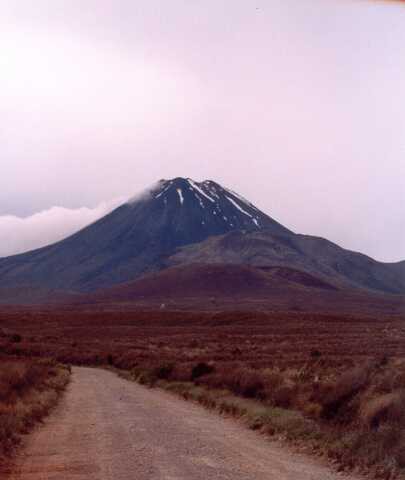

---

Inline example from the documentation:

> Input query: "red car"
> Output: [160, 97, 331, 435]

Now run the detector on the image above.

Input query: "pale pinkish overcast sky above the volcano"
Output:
[0, 0, 405, 261]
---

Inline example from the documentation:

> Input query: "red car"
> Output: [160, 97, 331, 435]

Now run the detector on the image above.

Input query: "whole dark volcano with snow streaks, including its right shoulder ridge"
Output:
[0, 178, 405, 303]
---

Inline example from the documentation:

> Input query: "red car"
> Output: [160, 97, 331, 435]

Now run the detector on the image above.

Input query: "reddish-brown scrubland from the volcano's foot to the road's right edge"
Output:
[0, 308, 405, 479]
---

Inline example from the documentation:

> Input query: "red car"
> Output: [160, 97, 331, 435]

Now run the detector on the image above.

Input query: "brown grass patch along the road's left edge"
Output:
[0, 356, 70, 464]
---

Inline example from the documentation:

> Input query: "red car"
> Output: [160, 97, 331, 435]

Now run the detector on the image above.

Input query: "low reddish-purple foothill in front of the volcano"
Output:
[76, 264, 405, 315]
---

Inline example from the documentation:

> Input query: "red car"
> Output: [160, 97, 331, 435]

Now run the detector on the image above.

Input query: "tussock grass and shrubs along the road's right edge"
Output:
[110, 360, 405, 479]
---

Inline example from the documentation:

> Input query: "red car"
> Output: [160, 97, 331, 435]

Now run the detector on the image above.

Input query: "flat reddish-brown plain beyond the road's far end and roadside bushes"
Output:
[0, 306, 405, 367]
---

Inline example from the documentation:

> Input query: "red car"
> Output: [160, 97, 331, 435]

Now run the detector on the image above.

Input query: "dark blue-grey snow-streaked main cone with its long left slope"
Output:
[0, 178, 292, 291]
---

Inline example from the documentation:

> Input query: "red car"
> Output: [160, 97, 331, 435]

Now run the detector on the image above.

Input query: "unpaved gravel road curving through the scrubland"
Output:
[6, 368, 354, 480]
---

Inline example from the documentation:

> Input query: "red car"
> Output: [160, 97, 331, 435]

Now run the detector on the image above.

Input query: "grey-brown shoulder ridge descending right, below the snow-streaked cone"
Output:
[167, 230, 405, 294]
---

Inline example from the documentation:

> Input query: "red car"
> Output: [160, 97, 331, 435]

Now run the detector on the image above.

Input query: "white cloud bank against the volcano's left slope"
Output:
[0, 198, 126, 257]
